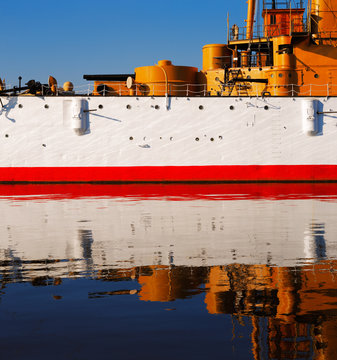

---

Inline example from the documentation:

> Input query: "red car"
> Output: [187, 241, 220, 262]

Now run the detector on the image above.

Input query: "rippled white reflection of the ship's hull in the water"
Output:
[0, 184, 337, 278]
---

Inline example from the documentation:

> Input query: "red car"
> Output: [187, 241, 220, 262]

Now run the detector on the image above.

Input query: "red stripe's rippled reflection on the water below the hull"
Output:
[0, 182, 337, 201]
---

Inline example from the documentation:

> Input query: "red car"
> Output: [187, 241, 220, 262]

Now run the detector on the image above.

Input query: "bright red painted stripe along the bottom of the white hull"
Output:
[0, 165, 337, 182]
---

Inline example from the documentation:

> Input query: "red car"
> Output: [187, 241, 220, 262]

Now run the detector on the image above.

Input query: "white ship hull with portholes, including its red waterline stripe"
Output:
[0, 96, 337, 182]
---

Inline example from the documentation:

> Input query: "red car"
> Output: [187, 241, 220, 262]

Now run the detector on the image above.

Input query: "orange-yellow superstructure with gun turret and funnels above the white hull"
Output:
[86, 0, 337, 97]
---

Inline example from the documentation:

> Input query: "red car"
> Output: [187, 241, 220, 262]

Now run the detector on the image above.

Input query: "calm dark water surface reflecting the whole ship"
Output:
[0, 184, 337, 359]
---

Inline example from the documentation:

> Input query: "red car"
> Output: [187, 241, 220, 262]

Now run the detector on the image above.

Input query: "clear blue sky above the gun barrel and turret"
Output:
[0, 0, 246, 85]
